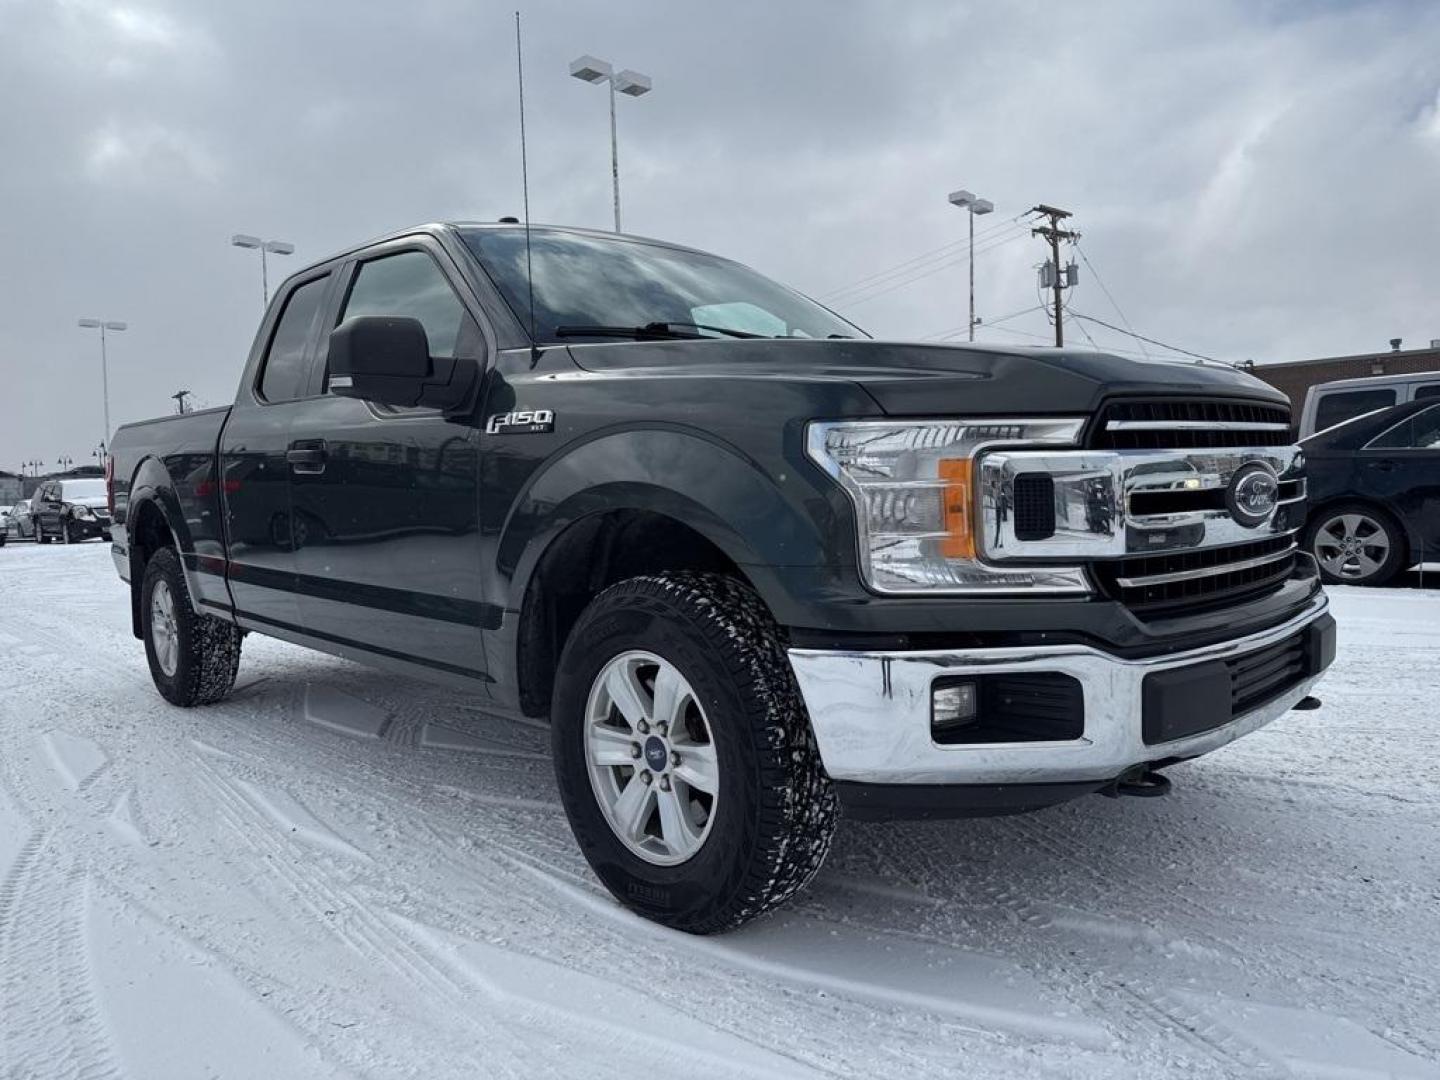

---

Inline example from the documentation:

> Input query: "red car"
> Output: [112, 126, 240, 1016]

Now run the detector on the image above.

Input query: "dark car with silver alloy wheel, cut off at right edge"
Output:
[1300, 397, 1440, 585]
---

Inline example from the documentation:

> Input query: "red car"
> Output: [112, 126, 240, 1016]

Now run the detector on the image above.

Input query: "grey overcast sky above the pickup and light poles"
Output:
[0, 0, 1440, 471]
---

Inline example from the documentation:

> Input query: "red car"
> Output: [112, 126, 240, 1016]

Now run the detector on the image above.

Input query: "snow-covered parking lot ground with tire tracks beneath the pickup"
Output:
[0, 543, 1440, 1080]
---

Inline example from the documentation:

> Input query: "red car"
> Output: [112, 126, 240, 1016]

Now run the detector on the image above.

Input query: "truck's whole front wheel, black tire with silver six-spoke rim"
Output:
[550, 573, 838, 933]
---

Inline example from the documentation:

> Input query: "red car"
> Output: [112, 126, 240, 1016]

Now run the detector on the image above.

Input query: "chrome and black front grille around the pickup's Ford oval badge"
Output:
[978, 400, 1306, 618]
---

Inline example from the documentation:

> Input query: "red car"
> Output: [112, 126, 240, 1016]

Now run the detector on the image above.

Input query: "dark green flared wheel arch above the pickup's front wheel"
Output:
[497, 426, 854, 622]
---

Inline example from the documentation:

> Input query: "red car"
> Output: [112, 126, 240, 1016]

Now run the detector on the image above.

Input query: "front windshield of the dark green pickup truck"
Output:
[459, 229, 864, 344]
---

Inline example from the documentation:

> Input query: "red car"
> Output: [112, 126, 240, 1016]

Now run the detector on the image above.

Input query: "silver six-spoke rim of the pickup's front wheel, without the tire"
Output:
[582, 649, 720, 867]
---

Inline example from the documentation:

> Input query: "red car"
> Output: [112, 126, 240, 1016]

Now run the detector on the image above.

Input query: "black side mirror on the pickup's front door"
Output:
[330, 315, 480, 410]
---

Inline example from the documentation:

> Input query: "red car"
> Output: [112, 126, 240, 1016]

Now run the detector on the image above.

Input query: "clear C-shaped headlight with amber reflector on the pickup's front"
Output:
[805, 419, 1090, 593]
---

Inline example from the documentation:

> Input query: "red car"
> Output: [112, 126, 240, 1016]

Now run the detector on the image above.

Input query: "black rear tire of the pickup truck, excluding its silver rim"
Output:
[140, 547, 242, 707]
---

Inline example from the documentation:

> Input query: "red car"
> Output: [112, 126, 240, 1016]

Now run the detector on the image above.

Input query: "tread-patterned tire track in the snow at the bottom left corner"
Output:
[0, 832, 124, 1080]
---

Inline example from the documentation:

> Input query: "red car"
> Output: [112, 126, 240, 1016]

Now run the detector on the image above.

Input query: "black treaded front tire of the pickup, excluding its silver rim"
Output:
[550, 573, 838, 933]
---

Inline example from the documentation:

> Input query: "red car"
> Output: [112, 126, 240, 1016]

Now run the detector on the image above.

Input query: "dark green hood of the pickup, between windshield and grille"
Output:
[570, 338, 1287, 416]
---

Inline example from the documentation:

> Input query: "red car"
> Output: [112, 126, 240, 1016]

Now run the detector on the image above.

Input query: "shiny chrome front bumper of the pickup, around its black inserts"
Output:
[789, 593, 1329, 783]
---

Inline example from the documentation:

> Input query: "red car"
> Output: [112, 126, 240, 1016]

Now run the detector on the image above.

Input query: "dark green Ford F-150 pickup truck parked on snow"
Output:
[109, 223, 1335, 933]
